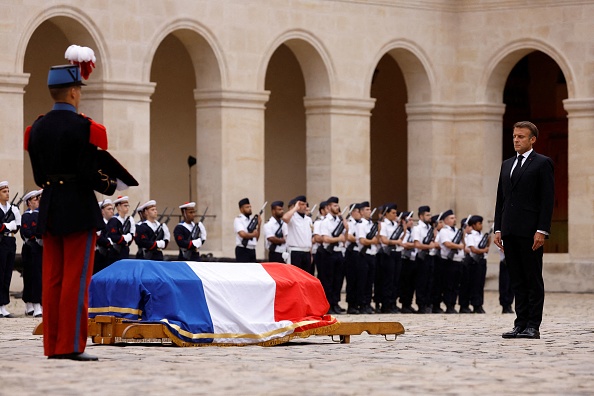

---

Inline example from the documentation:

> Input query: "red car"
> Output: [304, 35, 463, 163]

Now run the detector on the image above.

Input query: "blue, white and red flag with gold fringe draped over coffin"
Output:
[89, 260, 338, 345]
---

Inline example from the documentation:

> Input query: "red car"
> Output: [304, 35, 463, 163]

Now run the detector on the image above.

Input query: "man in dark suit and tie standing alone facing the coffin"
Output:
[494, 121, 555, 339]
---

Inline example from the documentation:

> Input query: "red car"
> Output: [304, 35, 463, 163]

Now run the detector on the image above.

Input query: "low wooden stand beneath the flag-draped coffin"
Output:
[33, 316, 404, 347]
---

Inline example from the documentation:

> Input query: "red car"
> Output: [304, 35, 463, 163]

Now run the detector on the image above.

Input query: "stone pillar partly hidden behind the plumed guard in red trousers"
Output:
[84, 81, 155, 206]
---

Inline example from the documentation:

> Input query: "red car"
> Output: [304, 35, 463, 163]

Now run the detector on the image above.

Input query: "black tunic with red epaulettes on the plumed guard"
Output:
[25, 110, 116, 235]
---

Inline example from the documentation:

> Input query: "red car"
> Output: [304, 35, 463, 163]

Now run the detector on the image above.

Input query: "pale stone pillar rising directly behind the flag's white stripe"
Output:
[194, 90, 270, 258]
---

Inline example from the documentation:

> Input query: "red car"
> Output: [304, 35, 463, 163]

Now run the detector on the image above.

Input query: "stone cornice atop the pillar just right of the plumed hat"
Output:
[83, 81, 156, 102]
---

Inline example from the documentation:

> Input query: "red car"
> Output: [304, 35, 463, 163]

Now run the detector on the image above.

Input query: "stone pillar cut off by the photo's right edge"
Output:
[563, 98, 594, 292]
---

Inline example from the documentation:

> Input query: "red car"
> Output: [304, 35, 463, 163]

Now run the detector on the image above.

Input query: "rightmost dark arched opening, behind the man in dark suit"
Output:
[502, 51, 568, 253]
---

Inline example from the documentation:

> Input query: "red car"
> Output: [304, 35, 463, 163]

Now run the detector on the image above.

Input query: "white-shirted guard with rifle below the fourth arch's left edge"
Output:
[357, 201, 379, 314]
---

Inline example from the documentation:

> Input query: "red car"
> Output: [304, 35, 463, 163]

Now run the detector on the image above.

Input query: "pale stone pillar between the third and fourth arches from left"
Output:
[304, 97, 375, 205]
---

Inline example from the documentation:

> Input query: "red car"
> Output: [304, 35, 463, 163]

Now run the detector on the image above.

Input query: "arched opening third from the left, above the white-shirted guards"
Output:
[264, 44, 307, 207]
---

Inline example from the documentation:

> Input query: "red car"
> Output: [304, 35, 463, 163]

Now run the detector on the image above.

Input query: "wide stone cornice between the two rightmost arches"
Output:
[406, 103, 505, 121]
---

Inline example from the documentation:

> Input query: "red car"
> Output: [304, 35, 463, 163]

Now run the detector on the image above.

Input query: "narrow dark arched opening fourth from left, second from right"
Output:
[371, 54, 408, 210]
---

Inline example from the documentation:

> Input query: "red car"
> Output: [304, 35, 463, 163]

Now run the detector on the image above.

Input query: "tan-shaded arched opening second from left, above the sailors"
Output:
[150, 34, 197, 210]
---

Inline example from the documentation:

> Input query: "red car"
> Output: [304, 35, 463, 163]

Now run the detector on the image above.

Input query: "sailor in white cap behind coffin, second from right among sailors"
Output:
[134, 199, 171, 261]
